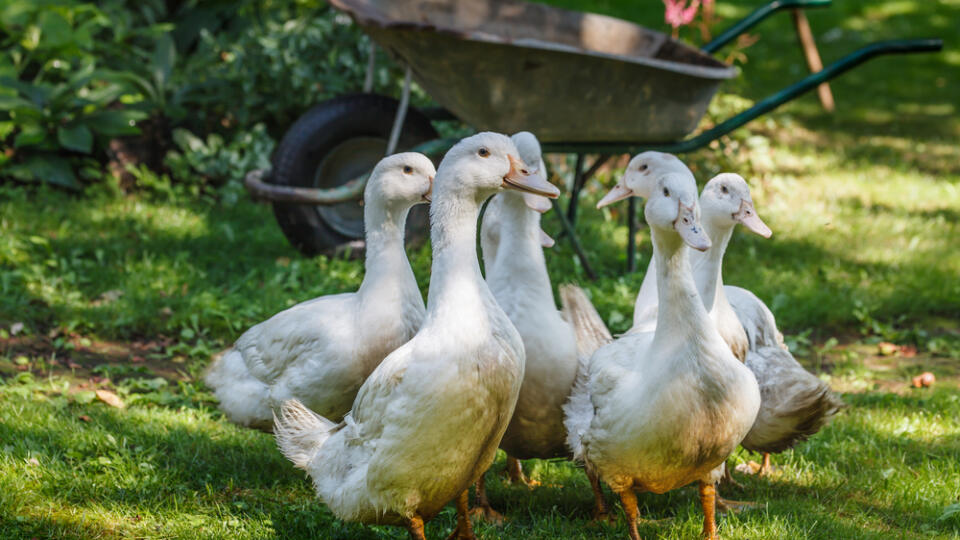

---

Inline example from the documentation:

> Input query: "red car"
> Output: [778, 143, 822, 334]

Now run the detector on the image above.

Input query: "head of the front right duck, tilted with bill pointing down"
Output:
[643, 174, 710, 251]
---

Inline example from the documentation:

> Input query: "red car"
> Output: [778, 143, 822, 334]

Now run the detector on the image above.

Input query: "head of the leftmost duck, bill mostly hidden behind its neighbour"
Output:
[363, 152, 437, 207]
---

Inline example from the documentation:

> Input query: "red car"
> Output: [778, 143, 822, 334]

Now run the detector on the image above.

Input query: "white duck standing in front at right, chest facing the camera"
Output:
[561, 173, 760, 540]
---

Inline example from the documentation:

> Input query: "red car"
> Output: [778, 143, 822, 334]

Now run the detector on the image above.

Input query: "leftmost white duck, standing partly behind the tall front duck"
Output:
[205, 152, 436, 430]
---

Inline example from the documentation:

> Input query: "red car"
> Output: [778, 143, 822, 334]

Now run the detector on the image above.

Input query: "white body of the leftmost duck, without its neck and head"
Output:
[207, 282, 423, 429]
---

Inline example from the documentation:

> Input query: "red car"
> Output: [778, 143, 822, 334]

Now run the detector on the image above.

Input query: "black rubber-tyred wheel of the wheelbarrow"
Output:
[272, 94, 437, 256]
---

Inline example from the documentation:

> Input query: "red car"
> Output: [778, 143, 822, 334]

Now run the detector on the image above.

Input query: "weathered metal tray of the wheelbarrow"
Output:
[330, 0, 737, 143]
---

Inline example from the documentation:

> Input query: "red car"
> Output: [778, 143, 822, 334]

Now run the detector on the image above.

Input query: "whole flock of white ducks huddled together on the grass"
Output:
[206, 132, 842, 540]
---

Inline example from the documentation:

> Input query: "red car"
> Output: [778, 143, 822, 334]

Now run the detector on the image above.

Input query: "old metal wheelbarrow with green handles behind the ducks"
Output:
[246, 0, 942, 277]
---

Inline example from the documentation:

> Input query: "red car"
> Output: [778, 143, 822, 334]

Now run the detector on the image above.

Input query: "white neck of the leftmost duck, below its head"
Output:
[358, 202, 417, 296]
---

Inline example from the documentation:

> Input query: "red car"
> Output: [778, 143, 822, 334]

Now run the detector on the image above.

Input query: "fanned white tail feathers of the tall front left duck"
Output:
[273, 399, 343, 470]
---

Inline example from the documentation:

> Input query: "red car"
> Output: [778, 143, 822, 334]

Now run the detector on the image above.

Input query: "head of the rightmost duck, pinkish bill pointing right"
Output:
[700, 173, 773, 238]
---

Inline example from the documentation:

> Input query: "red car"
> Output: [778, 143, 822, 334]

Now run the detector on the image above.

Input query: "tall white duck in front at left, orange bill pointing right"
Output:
[274, 133, 559, 539]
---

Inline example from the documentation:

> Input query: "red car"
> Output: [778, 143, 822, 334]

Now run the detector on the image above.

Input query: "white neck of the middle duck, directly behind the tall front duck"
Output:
[483, 192, 555, 308]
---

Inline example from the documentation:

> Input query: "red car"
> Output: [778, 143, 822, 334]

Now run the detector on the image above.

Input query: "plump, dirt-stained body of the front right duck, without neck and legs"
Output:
[583, 245, 759, 493]
